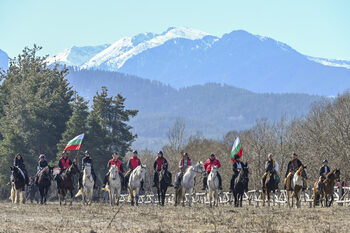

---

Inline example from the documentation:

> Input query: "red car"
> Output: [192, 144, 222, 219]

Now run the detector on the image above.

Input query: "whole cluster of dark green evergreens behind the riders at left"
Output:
[0, 45, 138, 196]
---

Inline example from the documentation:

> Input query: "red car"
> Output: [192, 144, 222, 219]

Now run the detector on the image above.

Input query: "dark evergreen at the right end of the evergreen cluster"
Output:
[84, 87, 138, 176]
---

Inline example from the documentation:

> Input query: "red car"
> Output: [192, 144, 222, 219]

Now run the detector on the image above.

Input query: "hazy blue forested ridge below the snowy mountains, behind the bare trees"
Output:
[67, 69, 322, 150]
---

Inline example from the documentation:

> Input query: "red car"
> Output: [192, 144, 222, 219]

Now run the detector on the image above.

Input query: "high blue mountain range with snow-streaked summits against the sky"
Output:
[48, 27, 350, 96]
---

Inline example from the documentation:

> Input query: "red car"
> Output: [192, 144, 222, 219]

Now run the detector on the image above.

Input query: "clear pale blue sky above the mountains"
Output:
[0, 0, 350, 60]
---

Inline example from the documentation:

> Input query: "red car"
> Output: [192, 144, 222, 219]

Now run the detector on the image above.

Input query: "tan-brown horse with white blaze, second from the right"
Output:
[286, 165, 307, 208]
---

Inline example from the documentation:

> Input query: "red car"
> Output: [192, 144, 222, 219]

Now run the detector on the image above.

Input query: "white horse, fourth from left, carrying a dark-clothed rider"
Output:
[75, 163, 95, 205]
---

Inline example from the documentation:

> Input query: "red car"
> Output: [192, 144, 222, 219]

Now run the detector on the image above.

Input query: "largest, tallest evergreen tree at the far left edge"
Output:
[0, 45, 73, 187]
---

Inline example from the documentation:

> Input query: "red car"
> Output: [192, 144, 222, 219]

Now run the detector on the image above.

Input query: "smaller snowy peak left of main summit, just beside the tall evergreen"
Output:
[47, 44, 110, 66]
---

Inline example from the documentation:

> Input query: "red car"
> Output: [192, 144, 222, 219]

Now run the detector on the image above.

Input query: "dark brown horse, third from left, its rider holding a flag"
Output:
[57, 162, 80, 205]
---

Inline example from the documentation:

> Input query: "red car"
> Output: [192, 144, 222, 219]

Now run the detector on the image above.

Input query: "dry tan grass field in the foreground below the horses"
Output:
[0, 202, 350, 233]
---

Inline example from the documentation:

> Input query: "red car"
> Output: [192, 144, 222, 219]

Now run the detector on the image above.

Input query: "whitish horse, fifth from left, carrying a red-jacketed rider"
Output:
[102, 165, 122, 205]
